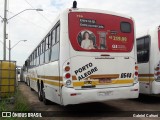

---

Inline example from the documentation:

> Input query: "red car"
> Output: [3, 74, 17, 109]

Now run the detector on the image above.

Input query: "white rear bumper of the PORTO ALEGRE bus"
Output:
[62, 82, 139, 105]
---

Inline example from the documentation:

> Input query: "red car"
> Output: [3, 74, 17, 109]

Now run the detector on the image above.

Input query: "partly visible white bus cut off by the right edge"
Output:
[137, 27, 160, 94]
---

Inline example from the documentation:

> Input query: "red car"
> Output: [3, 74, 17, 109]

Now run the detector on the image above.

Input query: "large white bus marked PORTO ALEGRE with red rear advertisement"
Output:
[25, 8, 139, 105]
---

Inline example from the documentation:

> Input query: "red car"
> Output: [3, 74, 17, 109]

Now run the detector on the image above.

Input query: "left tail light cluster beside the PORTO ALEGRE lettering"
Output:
[64, 62, 72, 87]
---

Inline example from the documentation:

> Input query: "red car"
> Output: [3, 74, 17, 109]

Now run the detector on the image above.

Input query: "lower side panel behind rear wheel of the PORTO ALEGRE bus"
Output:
[43, 61, 61, 104]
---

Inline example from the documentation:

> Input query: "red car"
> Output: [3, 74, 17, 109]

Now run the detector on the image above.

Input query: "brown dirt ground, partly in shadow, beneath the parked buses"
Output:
[19, 82, 160, 120]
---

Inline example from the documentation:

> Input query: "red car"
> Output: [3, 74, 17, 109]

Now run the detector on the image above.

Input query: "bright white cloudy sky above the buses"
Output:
[0, 0, 160, 66]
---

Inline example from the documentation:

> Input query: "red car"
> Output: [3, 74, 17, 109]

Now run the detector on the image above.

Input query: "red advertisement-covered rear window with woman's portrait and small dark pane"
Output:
[68, 12, 134, 52]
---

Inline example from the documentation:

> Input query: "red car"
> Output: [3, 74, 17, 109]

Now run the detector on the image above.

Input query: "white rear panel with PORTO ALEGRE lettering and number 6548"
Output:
[71, 56, 135, 89]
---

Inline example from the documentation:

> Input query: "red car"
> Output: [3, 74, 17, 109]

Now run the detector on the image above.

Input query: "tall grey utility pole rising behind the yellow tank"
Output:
[3, 0, 7, 60]
